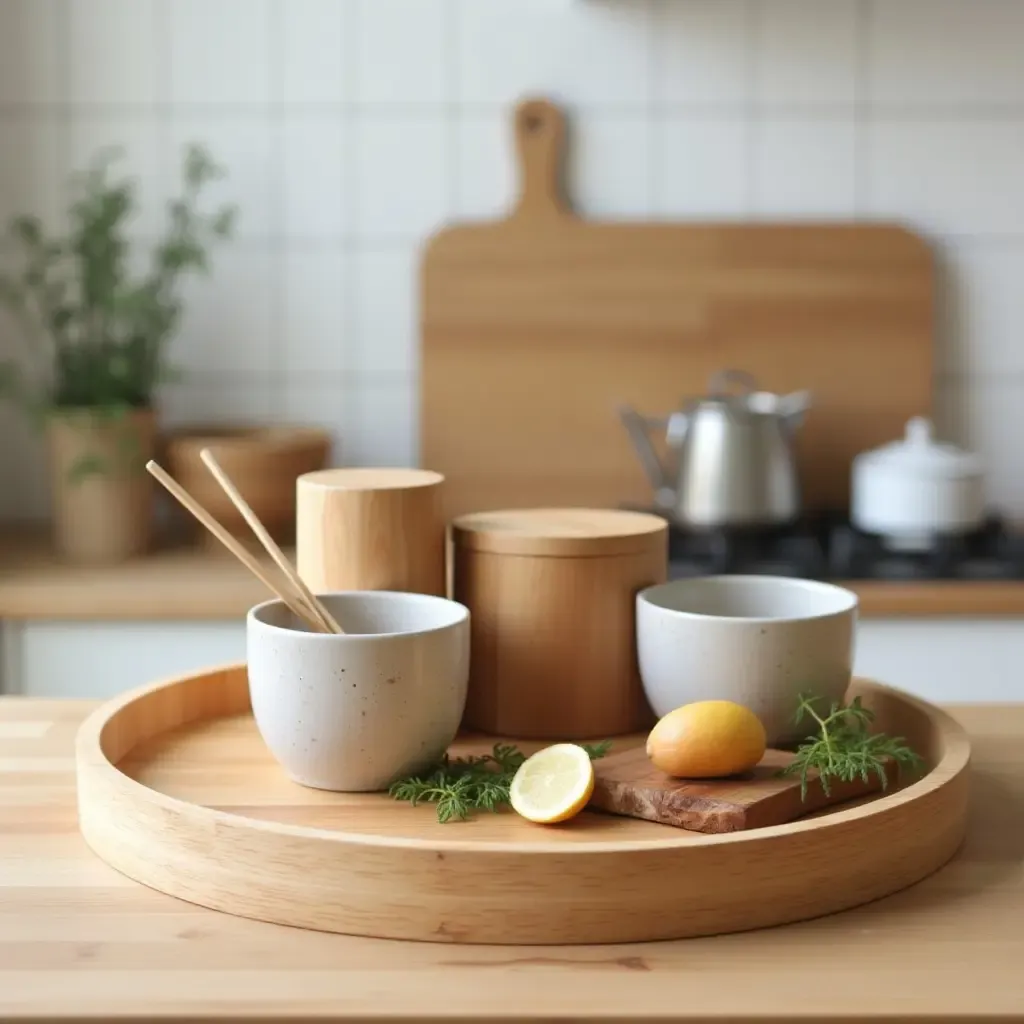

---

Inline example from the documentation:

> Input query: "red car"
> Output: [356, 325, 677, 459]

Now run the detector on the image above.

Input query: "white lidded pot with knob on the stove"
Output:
[850, 417, 985, 551]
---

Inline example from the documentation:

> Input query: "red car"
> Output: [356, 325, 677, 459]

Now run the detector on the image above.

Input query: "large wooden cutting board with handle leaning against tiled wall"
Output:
[420, 99, 934, 514]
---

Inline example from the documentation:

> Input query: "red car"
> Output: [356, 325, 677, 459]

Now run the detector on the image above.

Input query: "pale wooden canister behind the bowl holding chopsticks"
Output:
[295, 468, 446, 597]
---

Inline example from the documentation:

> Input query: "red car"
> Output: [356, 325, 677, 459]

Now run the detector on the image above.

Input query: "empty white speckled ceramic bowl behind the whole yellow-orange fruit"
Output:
[637, 575, 857, 743]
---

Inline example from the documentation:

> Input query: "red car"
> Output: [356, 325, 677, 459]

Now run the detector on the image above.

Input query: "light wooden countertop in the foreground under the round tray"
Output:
[0, 697, 1024, 1024]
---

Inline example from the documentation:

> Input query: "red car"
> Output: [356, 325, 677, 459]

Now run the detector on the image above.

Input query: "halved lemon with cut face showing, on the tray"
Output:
[509, 743, 594, 824]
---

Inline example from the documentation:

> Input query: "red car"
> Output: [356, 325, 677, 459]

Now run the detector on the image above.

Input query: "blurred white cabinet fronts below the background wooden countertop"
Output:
[0, 618, 1024, 703]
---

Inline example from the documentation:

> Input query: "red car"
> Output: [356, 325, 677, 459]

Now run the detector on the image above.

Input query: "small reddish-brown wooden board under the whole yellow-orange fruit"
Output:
[589, 746, 892, 833]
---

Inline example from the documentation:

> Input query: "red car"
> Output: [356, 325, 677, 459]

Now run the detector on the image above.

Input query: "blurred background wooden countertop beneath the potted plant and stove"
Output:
[0, 530, 1024, 621]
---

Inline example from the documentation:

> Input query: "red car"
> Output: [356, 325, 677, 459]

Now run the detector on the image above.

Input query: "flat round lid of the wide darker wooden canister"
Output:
[452, 508, 669, 558]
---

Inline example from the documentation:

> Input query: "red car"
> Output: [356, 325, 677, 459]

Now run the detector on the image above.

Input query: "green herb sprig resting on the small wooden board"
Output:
[779, 693, 924, 800]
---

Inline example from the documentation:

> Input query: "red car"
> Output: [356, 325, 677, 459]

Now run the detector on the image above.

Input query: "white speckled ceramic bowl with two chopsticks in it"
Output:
[246, 591, 469, 793]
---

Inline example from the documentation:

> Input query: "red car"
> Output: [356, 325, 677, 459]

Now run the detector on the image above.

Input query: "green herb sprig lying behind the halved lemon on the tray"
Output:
[389, 740, 611, 824]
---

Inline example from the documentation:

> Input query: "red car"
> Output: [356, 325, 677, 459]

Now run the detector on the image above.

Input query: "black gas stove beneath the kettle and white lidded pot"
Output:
[647, 512, 1024, 581]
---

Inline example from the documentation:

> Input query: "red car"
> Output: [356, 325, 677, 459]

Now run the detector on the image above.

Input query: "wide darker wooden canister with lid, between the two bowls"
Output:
[452, 508, 669, 740]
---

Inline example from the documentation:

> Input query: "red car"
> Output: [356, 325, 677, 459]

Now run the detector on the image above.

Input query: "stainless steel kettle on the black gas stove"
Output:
[620, 370, 810, 528]
